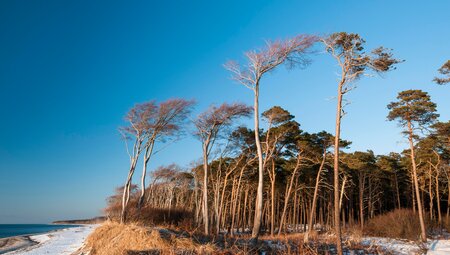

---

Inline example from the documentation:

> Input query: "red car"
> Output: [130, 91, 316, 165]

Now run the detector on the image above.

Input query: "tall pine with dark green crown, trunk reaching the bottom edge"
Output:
[322, 32, 400, 254]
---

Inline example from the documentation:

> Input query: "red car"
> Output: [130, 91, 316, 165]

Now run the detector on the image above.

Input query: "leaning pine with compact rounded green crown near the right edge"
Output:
[387, 90, 439, 242]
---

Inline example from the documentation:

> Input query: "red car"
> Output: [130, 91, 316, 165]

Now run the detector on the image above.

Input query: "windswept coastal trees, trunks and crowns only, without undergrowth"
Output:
[112, 32, 450, 254]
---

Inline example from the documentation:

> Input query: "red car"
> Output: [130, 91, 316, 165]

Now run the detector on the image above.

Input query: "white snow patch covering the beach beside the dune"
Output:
[7, 225, 97, 255]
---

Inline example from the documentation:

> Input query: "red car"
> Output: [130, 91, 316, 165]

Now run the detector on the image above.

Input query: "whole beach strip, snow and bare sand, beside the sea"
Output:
[0, 225, 97, 255]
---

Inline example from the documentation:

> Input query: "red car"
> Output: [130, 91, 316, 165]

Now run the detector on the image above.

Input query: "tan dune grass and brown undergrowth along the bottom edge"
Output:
[84, 221, 394, 255]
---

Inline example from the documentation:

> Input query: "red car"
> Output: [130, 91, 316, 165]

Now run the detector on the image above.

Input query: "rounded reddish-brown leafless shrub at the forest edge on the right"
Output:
[364, 209, 427, 240]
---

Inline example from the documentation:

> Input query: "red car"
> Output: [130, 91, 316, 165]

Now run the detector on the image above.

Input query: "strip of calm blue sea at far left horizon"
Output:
[0, 224, 77, 238]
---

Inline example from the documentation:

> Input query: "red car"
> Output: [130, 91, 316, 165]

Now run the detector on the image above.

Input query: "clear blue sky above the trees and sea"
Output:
[0, 0, 450, 224]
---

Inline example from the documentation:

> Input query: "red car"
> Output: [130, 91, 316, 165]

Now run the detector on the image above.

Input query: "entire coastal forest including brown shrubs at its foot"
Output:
[89, 32, 450, 254]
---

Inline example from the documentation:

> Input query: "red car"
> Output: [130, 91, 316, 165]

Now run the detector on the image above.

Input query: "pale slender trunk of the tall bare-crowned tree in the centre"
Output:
[252, 83, 264, 242]
